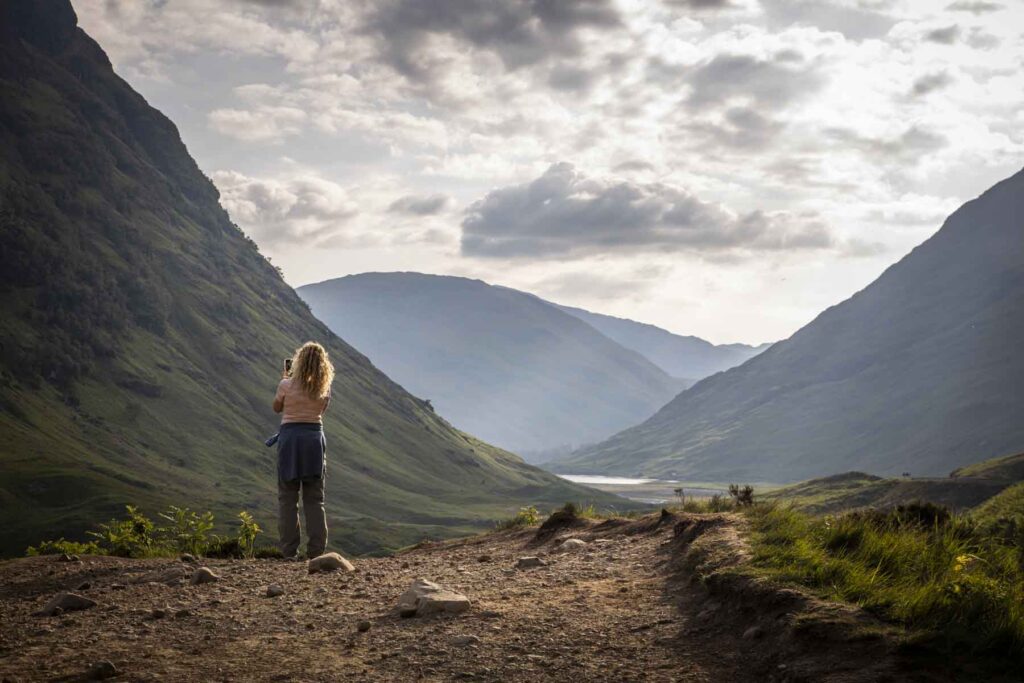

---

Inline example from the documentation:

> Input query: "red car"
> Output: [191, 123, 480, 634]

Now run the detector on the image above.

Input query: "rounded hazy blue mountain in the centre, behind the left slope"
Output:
[298, 272, 681, 454]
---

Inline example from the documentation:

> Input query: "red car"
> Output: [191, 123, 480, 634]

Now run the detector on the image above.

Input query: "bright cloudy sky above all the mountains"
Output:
[74, 0, 1024, 343]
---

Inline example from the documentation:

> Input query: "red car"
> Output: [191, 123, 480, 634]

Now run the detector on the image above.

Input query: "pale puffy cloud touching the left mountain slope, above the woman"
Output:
[213, 171, 357, 246]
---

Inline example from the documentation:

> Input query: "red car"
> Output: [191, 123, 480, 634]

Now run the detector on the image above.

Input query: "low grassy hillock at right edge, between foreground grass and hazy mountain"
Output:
[758, 454, 1024, 516]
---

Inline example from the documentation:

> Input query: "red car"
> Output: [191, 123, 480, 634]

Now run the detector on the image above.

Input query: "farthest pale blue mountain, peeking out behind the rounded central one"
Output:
[558, 306, 771, 383]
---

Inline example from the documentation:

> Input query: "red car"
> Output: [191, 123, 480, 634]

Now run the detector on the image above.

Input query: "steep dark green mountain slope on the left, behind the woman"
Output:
[0, 0, 612, 554]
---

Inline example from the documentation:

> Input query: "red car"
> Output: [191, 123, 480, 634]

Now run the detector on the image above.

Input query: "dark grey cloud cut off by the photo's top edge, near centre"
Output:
[366, 0, 620, 81]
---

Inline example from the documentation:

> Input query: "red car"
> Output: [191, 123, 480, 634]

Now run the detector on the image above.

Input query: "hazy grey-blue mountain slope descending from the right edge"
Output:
[558, 172, 1024, 481]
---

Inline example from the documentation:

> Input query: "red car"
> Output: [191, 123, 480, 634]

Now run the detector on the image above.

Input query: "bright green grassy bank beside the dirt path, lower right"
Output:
[746, 504, 1024, 658]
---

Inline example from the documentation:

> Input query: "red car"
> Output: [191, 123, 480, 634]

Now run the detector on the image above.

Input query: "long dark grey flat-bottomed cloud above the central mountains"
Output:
[462, 163, 837, 258]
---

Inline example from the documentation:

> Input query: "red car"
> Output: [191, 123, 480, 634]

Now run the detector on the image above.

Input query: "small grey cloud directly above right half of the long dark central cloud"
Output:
[687, 51, 824, 109]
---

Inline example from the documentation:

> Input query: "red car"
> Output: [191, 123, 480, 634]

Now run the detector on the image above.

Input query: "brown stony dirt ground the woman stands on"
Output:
[0, 518, 764, 683]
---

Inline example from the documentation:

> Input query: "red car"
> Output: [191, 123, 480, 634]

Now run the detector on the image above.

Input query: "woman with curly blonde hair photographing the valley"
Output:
[273, 342, 334, 559]
